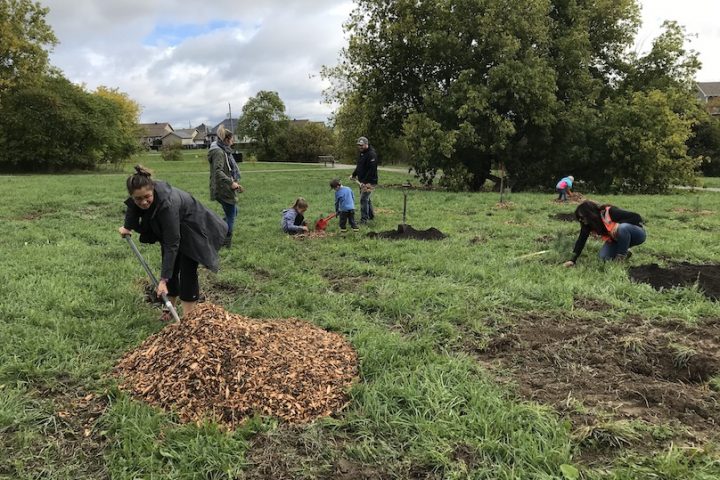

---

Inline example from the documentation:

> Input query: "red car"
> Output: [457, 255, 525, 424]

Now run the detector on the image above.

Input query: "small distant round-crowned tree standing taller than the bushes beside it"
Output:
[237, 90, 288, 161]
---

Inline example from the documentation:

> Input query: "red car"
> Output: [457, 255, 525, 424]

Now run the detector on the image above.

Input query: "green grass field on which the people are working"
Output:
[0, 153, 720, 480]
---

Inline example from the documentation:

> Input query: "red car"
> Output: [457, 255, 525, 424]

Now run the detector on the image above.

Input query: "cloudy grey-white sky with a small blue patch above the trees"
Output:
[40, 0, 720, 129]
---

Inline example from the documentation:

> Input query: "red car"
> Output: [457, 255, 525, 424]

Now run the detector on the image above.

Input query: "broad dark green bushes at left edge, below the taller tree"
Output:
[0, 75, 139, 172]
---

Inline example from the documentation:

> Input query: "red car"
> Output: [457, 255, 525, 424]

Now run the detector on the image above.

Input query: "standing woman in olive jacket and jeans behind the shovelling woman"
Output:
[208, 125, 244, 248]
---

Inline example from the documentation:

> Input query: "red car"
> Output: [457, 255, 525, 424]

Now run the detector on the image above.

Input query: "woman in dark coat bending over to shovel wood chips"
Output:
[119, 165, 227, 320]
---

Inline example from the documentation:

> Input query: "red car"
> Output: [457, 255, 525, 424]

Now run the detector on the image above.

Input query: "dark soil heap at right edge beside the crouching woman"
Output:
[629, 262, 720, 300]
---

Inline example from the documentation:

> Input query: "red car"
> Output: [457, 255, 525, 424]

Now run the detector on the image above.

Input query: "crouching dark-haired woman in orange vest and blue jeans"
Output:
[564, 200, 646, 267]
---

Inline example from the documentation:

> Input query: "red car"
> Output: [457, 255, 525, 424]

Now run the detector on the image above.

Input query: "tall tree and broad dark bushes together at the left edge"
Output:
[0, 0, 140, 172]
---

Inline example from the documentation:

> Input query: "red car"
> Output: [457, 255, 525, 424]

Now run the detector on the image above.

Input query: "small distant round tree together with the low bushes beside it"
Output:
[236, 90, 334, 162]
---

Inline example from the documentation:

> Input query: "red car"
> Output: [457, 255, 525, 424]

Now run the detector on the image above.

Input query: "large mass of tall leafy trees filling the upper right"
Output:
[324, 0, 713, 192]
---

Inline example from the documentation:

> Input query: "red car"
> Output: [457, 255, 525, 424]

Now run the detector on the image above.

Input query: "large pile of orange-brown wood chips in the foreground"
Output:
[115, 304, 357, 428]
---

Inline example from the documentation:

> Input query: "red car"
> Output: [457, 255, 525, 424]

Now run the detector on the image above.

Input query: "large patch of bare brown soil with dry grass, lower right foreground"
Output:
[470, 316, 720, 456]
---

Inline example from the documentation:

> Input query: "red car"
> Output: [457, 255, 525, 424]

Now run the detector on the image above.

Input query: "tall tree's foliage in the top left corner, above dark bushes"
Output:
[0, 0, 57, 96]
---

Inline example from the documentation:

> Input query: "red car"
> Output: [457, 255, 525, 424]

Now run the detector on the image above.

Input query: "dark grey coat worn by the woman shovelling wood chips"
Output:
[125, 181, 227, 278]
